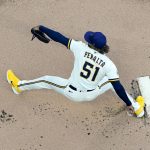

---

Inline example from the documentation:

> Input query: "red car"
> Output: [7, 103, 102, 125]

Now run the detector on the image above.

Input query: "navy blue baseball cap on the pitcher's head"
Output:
[84, 31, 107, 49]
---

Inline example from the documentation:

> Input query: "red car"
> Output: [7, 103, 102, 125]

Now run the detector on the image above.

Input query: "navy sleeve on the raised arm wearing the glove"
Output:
[39, 25, 69, 47]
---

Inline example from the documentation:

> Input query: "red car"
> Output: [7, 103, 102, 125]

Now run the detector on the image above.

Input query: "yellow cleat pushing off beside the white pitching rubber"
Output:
[135, 96, 145, 117]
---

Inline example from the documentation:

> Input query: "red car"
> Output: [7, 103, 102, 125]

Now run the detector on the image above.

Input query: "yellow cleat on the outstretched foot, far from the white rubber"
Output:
[7, 70, 21, 94]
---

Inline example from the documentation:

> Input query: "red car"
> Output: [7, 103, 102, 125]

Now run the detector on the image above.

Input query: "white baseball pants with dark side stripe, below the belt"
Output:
[18, 75, 114, 102]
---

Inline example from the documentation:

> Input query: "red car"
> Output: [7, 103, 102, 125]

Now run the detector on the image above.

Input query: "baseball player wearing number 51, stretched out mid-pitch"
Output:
[7, 25, 144, 117]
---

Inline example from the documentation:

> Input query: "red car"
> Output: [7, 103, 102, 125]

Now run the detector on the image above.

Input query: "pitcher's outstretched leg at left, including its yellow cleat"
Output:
[7, 70, 68, 94]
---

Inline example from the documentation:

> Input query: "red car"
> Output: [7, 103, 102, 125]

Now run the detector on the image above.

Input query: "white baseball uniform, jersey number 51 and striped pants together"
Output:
[18, 39, 119, 101]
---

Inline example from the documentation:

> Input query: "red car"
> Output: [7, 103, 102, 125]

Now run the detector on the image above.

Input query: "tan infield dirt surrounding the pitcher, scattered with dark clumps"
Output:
[0, 0, 150, 150]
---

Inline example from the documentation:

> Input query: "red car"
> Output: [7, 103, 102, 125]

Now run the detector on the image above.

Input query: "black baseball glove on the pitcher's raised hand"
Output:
[31, 27, 50, 43]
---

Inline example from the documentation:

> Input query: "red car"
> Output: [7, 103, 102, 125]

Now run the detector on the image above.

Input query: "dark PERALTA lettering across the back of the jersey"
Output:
[84, 52, 105, 67]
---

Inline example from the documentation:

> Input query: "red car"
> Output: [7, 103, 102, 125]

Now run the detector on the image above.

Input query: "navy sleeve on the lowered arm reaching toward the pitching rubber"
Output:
[111, 81, 131, 106]
